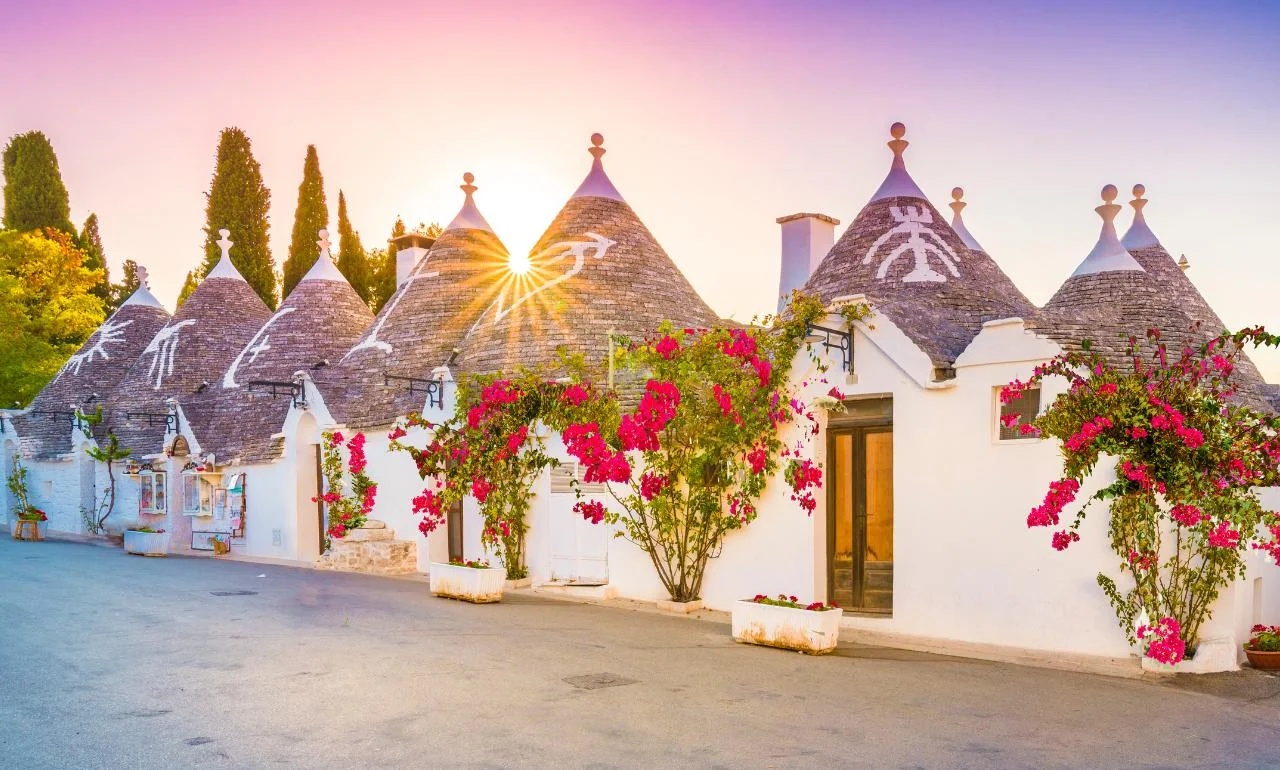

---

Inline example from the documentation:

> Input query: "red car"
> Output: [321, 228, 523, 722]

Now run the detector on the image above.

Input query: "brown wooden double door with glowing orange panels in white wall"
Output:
[827, 399, 893, 614]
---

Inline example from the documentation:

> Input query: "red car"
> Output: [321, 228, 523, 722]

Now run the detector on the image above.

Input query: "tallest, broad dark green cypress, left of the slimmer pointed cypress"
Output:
[198, 128, 273, 305]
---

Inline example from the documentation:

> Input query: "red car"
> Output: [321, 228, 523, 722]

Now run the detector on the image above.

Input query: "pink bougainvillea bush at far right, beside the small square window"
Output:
[1001, 323, 1280, 664]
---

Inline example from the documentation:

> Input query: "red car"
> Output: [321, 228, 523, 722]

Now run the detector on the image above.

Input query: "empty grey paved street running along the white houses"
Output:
[0, 537, 1280, 769]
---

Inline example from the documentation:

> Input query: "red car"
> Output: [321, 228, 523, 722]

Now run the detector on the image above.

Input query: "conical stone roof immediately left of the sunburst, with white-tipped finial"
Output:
[332, 174, 511, 427]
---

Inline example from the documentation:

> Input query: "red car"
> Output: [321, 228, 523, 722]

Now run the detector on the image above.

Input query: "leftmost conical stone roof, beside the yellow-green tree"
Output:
[13, 278, 169, 459]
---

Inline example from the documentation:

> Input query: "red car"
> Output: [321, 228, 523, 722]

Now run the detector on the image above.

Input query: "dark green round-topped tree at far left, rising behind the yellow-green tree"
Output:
[4, 130, 76, 235]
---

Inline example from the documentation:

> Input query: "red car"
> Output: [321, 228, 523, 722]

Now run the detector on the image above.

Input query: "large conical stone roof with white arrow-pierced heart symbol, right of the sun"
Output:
[458, 134, 718, 372]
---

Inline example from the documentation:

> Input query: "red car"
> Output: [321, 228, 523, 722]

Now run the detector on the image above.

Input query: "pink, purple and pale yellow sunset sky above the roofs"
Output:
[0, 0, 1280, 381]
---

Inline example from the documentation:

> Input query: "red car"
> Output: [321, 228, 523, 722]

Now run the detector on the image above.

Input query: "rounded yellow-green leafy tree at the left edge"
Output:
[0, 228, 105, 407]
